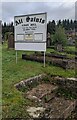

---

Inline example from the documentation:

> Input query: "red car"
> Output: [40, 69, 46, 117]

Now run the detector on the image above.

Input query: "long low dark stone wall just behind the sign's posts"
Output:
[22, 54, 75, 69]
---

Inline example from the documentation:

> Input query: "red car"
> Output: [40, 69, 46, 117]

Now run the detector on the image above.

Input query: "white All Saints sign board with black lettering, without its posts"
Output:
[14, 13, 47, 51]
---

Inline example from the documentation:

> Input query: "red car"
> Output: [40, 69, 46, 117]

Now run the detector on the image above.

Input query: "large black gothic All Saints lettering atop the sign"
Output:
[15, 16, 45, 26]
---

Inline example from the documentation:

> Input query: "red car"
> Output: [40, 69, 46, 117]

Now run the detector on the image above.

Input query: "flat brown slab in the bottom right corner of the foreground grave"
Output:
[41, 97, 76, 120]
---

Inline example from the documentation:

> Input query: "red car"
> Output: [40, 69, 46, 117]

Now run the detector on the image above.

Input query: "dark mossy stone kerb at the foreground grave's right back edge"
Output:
[51, 76, 77, 95]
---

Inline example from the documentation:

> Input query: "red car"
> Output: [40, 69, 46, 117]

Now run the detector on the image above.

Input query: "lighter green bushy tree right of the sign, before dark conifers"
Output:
[53, 26, 67, 46]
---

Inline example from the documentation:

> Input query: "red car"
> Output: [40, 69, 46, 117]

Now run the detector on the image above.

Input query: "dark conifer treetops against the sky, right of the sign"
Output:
[47, 19, 77, 34]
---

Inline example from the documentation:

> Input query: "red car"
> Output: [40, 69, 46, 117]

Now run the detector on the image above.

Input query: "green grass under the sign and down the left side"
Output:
[0, 44, 75, 118]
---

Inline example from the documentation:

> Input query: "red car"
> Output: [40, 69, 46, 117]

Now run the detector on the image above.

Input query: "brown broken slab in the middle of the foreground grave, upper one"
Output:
[25, 83, 58, 102]
